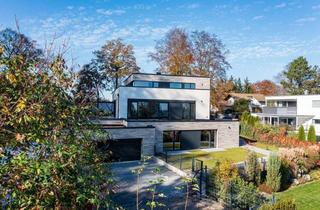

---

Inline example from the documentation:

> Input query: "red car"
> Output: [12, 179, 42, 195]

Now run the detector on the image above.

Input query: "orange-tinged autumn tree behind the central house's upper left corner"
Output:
[93, 39, 139, 91]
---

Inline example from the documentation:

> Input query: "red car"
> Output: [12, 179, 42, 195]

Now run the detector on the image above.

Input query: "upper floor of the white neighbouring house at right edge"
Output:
[263, 95, 320, 116]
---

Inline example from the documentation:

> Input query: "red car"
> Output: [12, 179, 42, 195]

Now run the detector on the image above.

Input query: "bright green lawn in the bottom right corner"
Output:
[277, 181, 320, 210]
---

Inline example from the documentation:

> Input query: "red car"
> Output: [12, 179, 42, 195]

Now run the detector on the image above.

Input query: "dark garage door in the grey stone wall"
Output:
[109, 139, 142, 161]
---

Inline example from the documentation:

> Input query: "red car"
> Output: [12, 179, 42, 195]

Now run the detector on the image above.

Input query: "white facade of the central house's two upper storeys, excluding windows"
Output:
[113, 73, 210, 120]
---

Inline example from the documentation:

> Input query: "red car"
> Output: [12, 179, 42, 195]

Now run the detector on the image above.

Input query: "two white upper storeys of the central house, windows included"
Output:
[113, 73, 210, 120]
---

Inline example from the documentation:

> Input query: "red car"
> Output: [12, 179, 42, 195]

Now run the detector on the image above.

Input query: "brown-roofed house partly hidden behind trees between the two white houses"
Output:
[224, 93, 265, 113]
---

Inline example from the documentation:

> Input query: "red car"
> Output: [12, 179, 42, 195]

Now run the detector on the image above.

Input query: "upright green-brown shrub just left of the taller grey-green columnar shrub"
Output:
[245, 152, 261, 185]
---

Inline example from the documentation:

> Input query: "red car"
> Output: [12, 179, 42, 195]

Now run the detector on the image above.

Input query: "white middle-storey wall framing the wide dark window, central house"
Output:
[114, 87, 210, 120]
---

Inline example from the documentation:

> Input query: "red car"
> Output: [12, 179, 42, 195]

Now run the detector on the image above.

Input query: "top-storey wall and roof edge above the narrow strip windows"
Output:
[125, 73, 210, 90]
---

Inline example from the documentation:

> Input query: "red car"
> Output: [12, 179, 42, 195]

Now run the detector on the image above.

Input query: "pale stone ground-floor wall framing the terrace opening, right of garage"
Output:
[128, 121, 239, 152]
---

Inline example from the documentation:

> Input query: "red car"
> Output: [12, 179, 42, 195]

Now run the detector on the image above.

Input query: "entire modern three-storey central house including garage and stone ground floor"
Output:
[97, 73, 239, 160]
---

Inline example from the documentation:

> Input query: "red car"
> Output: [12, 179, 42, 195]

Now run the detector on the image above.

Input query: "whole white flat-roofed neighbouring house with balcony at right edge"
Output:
[256, 95, 320, 138]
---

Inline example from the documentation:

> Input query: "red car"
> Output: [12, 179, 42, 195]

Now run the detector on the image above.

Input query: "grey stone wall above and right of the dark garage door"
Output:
[106, 127, 155, 155]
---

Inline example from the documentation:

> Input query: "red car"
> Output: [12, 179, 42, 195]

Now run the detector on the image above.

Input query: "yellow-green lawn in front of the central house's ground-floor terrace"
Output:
[164, 148, 263, 169]
